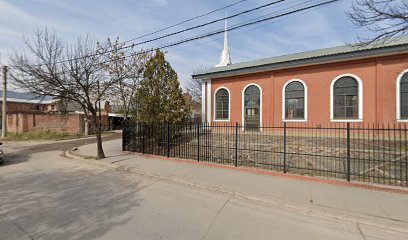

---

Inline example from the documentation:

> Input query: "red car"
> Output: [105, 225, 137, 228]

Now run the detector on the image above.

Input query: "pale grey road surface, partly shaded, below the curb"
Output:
[0, 136, 406, 240]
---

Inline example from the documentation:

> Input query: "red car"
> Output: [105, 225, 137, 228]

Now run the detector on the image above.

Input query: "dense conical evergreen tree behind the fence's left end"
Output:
[136, 50, 190, 123]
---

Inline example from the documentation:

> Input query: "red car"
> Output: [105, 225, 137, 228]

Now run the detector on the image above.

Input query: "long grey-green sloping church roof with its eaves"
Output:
[192, 37, 408, 79]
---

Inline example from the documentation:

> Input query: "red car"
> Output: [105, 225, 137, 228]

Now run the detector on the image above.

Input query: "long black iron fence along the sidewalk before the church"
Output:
[123, 122, 408, 187]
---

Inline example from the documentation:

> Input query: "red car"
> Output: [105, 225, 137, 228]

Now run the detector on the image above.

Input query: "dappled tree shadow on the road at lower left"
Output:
[0, 162, 146, 239]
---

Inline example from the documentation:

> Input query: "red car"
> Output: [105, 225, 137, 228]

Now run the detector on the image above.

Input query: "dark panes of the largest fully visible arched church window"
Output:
[332, 76, 359, 119]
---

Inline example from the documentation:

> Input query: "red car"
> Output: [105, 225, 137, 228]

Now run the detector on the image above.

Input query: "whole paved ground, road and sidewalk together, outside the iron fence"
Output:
[0, 136, 408, 240]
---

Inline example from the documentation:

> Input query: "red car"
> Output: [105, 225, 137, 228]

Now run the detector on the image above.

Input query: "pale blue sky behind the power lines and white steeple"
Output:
[0, 0, 364, 89]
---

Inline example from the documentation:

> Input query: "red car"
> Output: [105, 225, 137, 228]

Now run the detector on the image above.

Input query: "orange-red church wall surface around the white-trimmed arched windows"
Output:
[209, 55, 408, 123]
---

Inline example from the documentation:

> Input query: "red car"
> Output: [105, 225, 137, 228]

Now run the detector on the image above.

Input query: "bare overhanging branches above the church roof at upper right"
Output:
[348, 0, 408, 44]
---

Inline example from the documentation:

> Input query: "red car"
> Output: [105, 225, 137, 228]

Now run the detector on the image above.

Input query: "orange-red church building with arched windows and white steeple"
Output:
[193, 26, 408, 127]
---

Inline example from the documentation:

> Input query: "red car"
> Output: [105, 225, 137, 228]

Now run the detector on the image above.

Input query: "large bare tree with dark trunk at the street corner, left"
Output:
[10, 29, 115, 159]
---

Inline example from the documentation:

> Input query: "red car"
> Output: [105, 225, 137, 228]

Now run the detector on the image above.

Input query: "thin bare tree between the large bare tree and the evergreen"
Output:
[97, 38, 151, 119]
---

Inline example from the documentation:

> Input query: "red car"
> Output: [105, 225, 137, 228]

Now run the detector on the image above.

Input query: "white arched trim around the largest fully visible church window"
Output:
[330, 73, 363, 122]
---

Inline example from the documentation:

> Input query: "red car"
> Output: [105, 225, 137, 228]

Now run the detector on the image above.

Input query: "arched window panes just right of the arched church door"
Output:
[284, 81, 306, 120]
